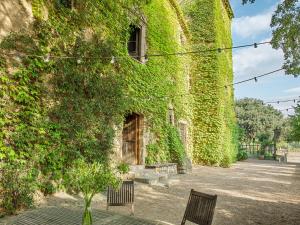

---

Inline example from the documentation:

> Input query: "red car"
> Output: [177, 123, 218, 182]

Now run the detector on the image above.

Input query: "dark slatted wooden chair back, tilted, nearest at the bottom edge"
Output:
[181, 189, 217, 225]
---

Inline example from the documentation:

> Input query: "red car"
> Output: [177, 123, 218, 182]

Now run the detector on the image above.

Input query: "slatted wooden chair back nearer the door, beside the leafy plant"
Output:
[107, 180, 134, 206]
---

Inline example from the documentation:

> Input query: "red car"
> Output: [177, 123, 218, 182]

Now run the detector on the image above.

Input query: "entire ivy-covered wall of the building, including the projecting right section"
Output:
[0, 0, 235, 171]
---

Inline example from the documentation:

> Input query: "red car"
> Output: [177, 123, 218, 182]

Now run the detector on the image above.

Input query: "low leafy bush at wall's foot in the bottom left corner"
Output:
[0, 164, 38, 214]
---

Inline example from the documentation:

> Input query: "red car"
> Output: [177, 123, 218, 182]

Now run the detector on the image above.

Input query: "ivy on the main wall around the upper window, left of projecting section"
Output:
[0, 0, 192, 213]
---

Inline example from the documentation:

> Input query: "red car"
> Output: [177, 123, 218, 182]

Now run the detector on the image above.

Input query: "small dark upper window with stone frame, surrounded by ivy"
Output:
[127, 25, 146, 63]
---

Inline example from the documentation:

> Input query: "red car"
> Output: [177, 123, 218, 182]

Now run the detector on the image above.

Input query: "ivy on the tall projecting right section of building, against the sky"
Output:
[184, 0, 237, 166]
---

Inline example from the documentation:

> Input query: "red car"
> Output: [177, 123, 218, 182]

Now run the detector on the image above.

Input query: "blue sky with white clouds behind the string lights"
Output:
[230, 0, 300, 115]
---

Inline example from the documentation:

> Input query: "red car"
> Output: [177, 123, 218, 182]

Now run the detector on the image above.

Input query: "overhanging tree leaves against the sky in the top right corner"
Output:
[243, 0, 300, 76]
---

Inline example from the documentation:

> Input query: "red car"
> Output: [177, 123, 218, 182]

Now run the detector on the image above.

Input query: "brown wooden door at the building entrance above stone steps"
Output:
[122, 113, 140, 164]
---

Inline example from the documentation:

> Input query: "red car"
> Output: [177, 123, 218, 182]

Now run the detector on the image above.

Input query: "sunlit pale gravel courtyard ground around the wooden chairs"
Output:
[0, 153, 300, 225]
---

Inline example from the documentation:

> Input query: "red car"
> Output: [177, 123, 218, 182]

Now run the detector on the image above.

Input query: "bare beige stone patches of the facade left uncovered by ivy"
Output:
[0, 0, 232, 164]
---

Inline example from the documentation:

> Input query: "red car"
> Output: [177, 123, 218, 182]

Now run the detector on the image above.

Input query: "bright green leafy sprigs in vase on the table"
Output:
[65, 160, 120, 225]
